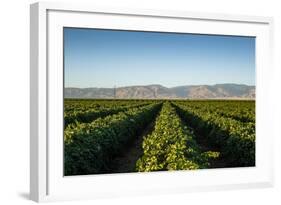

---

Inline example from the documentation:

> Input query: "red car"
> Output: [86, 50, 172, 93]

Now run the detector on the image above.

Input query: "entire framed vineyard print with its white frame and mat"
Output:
[30, 3, 273, 201]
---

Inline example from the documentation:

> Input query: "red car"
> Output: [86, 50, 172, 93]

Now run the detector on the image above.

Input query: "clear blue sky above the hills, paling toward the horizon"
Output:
[64, 28, 255, 88]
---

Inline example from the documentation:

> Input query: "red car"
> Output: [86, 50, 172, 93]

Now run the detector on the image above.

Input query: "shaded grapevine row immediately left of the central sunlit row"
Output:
[64, 102, 162, 175]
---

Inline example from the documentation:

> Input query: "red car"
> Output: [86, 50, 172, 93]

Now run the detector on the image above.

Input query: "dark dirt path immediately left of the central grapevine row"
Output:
[109, 119, 155, 173]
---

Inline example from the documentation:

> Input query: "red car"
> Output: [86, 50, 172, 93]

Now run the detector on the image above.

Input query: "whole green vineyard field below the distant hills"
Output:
[64, 99, 255, 175]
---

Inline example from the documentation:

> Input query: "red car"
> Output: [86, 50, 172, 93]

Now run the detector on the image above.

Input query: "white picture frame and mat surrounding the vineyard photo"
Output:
[30, 2, 273, 202]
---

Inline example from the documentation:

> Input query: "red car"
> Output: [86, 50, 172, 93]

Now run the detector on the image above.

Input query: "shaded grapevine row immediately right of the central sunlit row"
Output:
[174, 102, 255, 166]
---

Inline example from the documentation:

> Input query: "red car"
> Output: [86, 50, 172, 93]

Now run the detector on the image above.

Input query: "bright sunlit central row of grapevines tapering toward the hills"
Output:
[136, 102, 219, 171]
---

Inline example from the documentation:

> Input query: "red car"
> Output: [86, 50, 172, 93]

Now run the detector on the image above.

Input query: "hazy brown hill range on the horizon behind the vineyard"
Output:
[64, 84, 255, 99]
